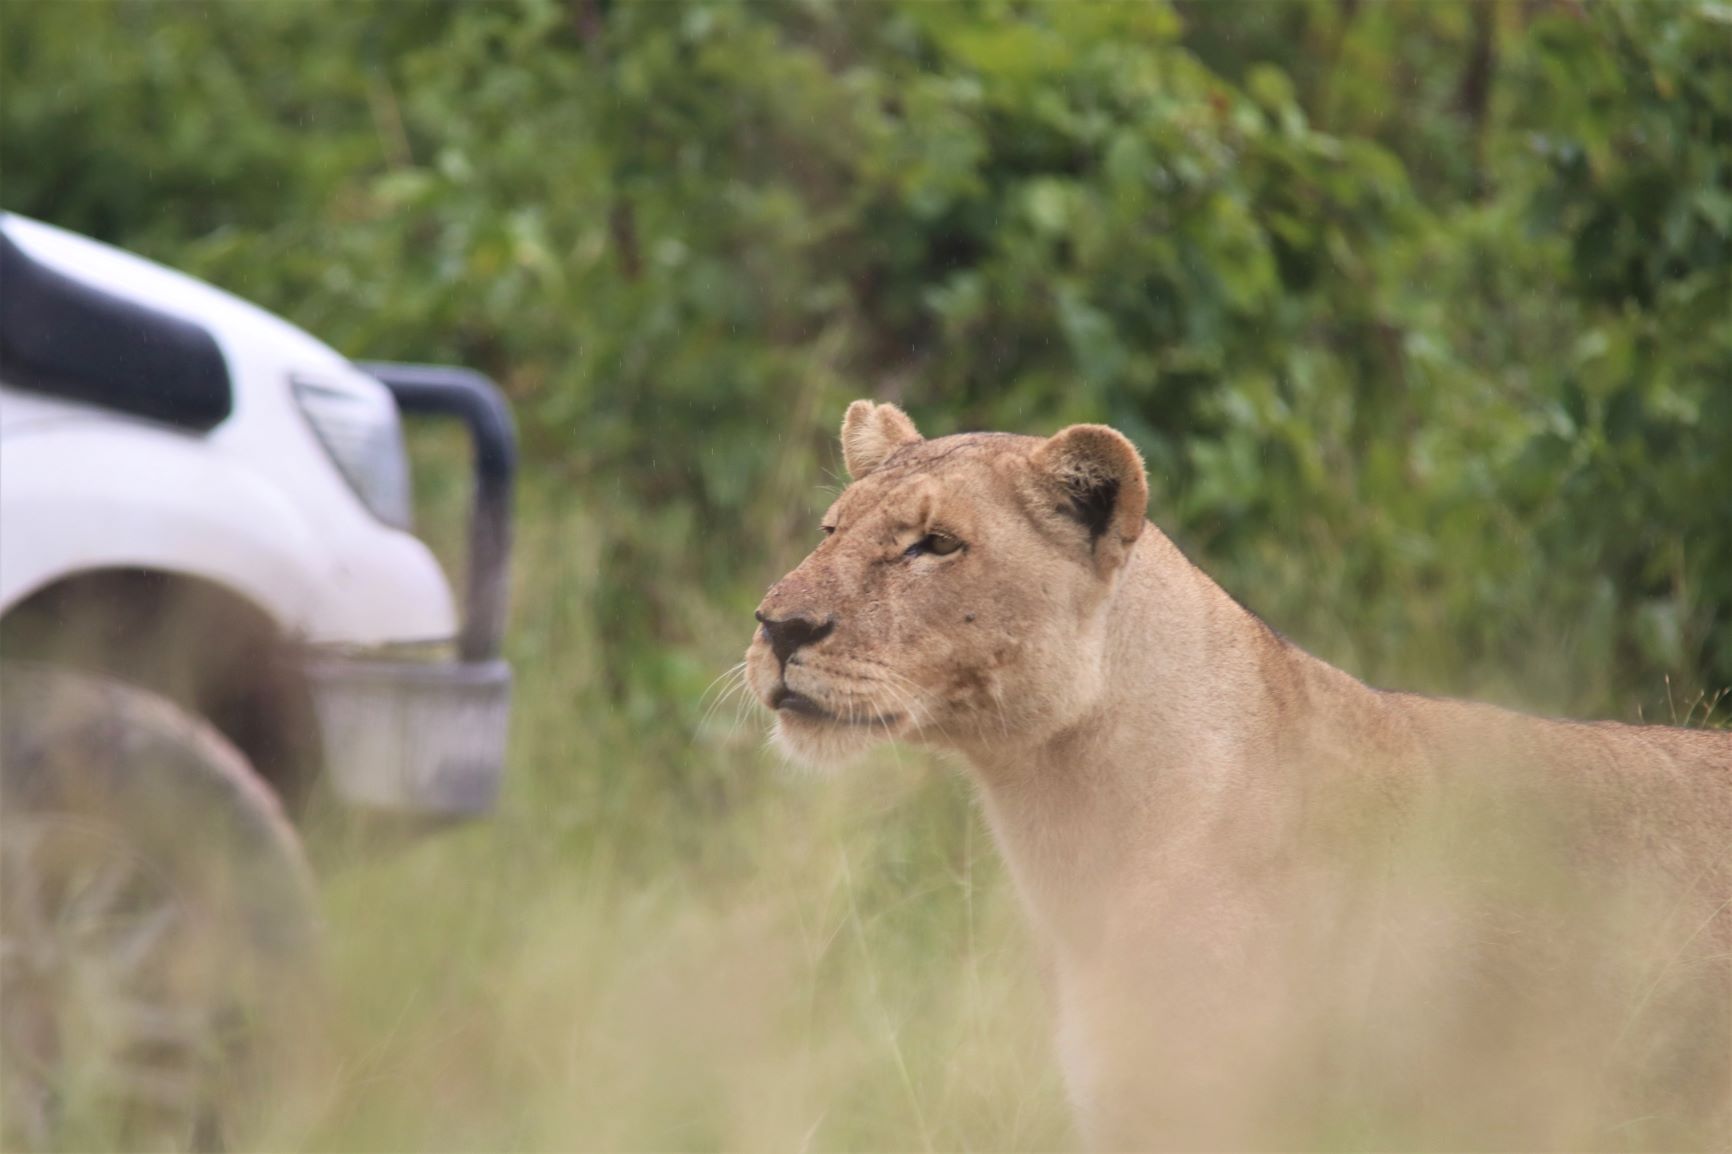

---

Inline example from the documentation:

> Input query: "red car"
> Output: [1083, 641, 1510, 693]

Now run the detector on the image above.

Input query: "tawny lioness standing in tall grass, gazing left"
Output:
[746, 400, 1732, 1149]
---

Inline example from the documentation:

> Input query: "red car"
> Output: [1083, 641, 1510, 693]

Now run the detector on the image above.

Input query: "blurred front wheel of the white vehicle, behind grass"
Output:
[0, 664, 319, 1149]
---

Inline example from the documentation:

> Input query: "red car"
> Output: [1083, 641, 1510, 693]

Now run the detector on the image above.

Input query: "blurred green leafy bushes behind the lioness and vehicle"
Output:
[0, 0, 1732, 717]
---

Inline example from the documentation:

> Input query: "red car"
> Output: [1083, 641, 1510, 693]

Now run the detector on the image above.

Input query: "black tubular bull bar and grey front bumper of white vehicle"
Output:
[307, 362, 516, 818]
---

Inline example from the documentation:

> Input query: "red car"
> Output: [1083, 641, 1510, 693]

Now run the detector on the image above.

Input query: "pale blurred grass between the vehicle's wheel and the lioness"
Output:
[297, 430, 1070, 1151]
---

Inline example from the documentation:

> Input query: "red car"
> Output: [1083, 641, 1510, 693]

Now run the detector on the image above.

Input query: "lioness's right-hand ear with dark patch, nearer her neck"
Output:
[1032, 425, 1148, 572]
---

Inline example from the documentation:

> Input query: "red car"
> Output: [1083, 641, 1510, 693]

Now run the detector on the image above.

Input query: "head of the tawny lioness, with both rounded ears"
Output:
[746, 400, 1148, 762]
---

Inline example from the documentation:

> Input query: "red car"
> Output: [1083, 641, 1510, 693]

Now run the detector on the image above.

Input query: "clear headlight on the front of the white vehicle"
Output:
[293, 379, 412, 528]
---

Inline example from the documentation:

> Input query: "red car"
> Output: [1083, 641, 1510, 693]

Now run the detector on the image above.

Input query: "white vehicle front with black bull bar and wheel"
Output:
[0, 215, 514, 1149]
